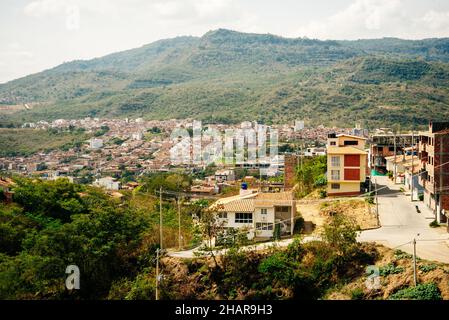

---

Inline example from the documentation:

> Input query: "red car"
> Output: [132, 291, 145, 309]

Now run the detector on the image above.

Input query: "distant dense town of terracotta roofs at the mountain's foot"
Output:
[0, 118, 351, 189]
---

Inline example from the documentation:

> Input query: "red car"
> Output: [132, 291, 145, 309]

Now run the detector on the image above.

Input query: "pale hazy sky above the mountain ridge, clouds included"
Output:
[0, 0, 449, 83]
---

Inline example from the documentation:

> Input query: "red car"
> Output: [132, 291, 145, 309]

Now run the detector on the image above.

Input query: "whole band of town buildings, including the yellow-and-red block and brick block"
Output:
[0, 118, 449, 235]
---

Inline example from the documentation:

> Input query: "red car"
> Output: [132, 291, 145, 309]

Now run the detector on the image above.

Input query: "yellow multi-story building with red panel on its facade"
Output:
[327, 134, 368, 196]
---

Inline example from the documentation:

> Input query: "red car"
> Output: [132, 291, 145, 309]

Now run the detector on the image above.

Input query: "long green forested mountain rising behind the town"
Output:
[0, 29, 449, 126]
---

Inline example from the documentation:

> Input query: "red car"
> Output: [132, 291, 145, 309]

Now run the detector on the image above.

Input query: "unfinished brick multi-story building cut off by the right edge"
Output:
[418, 122, 449, 222]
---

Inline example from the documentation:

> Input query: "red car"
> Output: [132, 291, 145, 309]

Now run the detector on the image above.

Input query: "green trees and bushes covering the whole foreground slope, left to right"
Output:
[0, 178, 448, 300]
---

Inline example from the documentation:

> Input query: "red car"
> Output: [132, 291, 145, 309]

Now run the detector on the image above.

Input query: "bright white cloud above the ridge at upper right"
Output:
[296, 0, 449, 39]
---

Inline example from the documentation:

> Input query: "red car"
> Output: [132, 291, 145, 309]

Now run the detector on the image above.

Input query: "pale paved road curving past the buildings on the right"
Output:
[359, 177, 449, 263]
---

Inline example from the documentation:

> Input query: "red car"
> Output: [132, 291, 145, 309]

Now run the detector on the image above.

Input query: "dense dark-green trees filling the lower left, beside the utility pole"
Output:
[0, 178, 192, 299]
